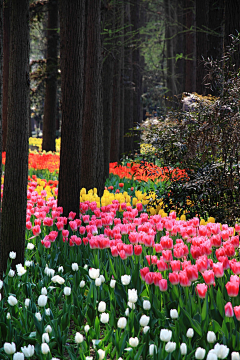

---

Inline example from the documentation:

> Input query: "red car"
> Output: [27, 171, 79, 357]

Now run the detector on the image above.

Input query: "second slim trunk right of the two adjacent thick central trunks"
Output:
[110, 0, 123, 162]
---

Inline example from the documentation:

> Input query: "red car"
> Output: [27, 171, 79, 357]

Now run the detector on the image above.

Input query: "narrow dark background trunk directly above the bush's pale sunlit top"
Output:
[196, 0, 209, 95]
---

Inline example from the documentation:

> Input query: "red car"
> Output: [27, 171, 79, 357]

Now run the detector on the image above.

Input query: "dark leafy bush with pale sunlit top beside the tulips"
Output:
[142, 38, 240, 223]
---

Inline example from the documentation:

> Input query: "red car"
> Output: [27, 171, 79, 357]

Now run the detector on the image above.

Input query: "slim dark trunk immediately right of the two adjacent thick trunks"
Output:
[102, 1, 115, 179]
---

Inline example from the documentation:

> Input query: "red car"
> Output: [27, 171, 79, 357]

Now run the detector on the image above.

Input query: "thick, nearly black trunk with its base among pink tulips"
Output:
[58, 0, 85, 216]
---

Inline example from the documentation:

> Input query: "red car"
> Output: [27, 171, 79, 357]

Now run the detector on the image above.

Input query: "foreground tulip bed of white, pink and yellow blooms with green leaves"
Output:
[0, 172, 240, 360]
